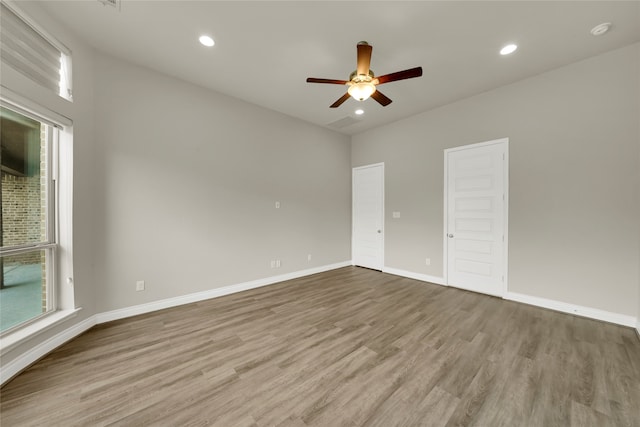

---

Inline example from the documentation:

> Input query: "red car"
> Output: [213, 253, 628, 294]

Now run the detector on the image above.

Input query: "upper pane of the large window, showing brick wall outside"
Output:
[0, 108, 47, 248]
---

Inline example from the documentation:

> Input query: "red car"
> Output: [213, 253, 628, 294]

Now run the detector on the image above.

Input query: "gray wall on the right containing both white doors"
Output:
[352, 44, 640, 317]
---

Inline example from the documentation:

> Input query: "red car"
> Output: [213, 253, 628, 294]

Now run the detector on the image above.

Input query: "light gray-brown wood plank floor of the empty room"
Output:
[0, 267, 640, 427]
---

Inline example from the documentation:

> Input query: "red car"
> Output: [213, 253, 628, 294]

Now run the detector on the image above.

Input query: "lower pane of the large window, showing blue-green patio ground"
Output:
[0, 249, 49, 332]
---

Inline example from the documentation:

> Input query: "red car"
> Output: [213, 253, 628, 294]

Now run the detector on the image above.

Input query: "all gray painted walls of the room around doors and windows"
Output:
[2, 2, 640, 382]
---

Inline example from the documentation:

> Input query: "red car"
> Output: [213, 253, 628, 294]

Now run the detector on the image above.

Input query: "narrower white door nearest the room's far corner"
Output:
[351, 163, 384, 270]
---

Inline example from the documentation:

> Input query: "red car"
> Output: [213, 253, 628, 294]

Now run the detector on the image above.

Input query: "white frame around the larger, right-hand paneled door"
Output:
[442, 138, 509, 298]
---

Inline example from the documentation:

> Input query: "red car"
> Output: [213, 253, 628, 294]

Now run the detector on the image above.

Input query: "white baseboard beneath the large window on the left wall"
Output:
[0, 316, 96, 385]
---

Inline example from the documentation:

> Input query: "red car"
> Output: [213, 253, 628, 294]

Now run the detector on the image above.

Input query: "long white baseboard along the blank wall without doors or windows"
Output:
[96, 261, 351, 324]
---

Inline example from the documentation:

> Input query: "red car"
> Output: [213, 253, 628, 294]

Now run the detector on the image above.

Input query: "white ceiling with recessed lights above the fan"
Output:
[33, 0, 640, 134]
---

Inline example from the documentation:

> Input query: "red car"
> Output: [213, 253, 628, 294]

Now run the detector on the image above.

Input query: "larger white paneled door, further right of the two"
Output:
[445, 139, 509, 296]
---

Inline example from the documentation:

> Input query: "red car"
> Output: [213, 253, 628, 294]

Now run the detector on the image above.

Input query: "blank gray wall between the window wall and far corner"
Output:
[94, 56, 351, 312]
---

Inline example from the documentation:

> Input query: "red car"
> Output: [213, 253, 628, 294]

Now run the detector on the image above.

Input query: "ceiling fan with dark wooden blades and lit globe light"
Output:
[307, 41, 422, 108]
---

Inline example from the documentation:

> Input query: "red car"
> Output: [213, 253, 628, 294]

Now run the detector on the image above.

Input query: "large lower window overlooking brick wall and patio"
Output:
[0, 106, 58, 333]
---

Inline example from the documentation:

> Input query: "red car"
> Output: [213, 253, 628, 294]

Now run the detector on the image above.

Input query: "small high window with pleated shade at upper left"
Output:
[0, 1, 72, 100]
